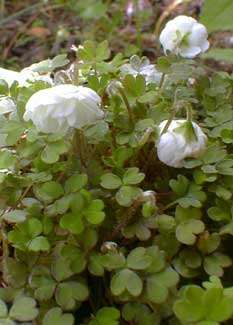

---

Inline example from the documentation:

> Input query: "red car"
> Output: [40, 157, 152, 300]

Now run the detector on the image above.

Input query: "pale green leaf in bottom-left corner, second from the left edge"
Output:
[9, 297, 38, 322]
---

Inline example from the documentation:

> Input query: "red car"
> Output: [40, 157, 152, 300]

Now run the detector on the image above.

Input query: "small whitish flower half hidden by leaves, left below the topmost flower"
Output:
[120, 55, 162, 84]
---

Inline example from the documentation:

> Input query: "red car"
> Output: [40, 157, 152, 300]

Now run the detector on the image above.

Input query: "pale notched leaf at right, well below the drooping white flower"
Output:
[176, 219, 205, 245]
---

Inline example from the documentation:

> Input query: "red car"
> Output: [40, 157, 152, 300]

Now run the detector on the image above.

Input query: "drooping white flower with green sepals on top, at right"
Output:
[156, 120, 207, 168]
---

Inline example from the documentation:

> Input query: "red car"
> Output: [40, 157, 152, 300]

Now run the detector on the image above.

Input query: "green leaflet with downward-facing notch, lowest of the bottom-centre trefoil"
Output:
[110, 269, 143, 297]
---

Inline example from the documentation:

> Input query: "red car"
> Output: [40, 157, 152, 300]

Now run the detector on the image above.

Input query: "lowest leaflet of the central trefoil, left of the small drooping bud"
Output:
[116, 186, 142, 207]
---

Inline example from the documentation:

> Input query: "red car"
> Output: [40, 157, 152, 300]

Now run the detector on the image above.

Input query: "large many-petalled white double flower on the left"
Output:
[24, 84, 104, 133]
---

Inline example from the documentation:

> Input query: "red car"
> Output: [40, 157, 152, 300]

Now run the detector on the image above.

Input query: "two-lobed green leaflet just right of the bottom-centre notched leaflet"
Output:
[146, 267, 179, 304]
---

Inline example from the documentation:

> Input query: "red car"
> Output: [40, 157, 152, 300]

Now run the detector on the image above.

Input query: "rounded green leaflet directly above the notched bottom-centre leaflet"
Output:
[127, 247, 152, 270]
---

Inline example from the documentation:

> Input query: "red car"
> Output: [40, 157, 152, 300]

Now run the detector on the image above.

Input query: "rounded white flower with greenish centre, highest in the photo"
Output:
[159, 16, 209, 58]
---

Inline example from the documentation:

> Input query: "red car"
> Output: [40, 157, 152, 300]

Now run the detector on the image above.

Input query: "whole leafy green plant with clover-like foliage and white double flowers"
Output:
[0, 16, 233, 325]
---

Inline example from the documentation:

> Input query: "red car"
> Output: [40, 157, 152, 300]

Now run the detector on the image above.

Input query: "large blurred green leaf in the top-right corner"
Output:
[200, 0, 233, 33]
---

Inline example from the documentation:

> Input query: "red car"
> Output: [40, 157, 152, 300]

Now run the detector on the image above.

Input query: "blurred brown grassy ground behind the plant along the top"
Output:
[0, 0, 233, 72]
